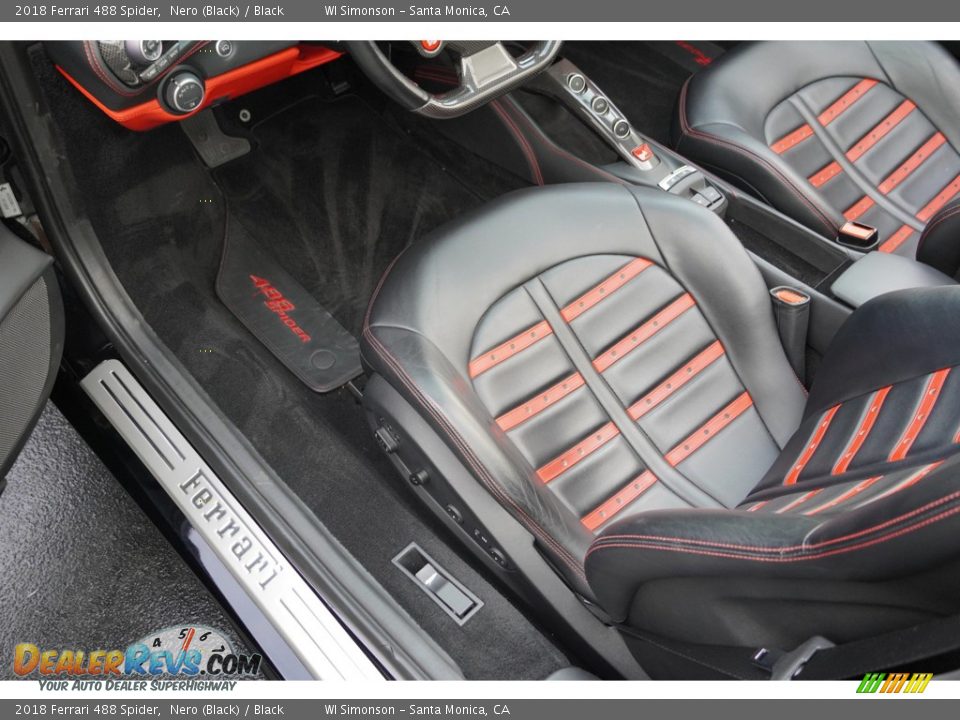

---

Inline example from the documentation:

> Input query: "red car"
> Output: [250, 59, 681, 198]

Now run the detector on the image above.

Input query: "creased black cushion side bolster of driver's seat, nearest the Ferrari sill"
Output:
[363, 325, 590, 594]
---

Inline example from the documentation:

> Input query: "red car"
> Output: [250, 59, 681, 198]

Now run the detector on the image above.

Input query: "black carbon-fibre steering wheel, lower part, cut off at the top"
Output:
[345, 40, 562, 119]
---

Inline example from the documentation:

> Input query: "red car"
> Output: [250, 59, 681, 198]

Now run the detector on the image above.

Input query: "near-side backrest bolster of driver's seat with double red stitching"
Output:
[586, 456, 960, 622]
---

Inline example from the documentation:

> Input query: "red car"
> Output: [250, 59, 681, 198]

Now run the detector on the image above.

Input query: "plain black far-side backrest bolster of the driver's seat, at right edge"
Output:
[804, 286, 960, 419]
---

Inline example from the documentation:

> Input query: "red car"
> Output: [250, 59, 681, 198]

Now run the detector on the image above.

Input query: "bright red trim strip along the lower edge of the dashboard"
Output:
[57, 45, 343, 130]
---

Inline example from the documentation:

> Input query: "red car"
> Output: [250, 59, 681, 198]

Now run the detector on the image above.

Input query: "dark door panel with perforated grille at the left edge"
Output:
[0, 225, 63, 478]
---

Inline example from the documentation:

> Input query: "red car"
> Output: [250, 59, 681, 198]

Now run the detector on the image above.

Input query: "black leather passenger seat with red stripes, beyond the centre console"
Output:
[675, 42, 960, 275]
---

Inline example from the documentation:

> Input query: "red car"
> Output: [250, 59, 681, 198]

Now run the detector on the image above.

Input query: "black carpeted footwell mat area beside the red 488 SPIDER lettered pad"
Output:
[214, 96, 519, 334]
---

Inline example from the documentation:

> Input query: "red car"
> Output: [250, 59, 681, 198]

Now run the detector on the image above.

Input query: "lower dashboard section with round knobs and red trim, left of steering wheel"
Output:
[44, 40, 342, 131]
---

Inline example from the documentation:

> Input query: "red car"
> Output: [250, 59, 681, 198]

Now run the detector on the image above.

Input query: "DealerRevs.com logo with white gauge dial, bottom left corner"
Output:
[13, 625, 261, 690]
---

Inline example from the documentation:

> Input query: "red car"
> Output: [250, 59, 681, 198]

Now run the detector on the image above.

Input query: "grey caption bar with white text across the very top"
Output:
[0, 0, 960, 23]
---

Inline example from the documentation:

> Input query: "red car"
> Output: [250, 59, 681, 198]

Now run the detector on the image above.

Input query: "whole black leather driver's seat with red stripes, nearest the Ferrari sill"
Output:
[362, 184, 960, 676]
